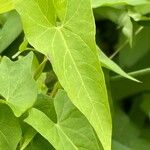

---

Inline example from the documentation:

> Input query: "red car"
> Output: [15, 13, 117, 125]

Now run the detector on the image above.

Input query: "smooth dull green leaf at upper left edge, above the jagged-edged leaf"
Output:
[0, 11, 22, 53]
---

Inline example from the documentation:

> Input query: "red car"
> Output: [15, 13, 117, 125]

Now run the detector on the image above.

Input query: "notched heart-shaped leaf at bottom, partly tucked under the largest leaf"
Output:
[25, 90, 100, 150]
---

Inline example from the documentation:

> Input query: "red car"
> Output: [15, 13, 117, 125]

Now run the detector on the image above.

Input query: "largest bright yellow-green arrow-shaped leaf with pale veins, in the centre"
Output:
[16, 0, 112, 150]
